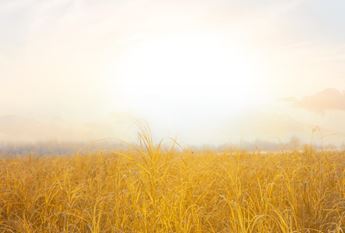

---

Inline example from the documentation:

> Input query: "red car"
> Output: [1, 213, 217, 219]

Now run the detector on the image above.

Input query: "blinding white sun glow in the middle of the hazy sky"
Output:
[110, 36, 263, 118]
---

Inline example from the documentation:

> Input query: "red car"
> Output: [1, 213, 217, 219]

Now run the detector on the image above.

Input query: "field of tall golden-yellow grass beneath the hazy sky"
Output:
[0, 139, 345, 233]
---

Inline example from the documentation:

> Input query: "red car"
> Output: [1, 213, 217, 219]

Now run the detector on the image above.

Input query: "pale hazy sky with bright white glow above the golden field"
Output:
[0, 0, 345, 145]
